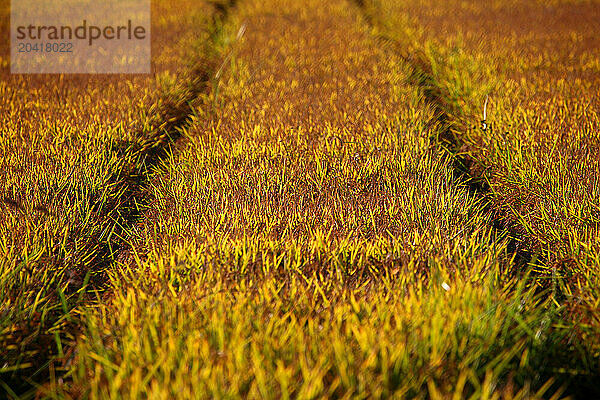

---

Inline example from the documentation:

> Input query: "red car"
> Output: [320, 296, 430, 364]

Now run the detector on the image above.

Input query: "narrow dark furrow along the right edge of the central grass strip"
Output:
[350, 0, 537, 274]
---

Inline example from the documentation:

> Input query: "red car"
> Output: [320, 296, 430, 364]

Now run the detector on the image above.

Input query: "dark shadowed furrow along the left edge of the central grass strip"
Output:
[0, 0, 236, 397]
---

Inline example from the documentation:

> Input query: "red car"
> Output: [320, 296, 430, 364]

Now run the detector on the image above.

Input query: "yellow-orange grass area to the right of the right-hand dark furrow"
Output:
[364, 0, 600, 390]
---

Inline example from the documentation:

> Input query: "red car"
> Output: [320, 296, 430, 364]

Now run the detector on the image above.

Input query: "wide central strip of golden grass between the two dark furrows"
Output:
[63, 1, 594, 398]
